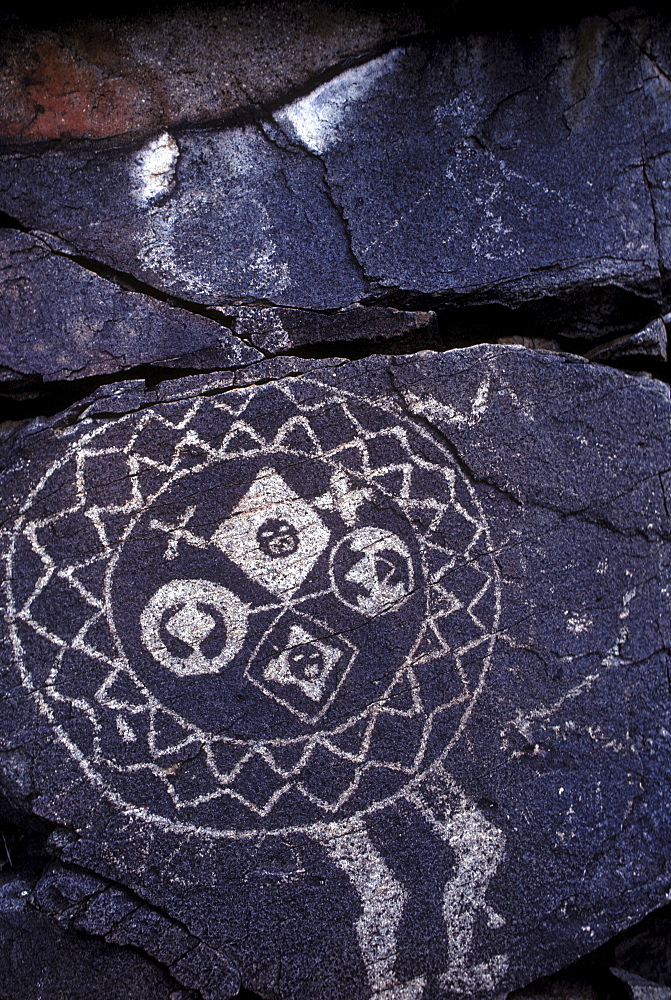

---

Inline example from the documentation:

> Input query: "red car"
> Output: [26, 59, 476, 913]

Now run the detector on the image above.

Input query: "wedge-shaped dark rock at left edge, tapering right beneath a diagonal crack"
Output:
[0, 229, 261, 381]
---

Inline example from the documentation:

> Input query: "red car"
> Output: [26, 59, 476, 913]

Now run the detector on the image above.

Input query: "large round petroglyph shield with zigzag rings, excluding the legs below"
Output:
[8, 379, 500, 836]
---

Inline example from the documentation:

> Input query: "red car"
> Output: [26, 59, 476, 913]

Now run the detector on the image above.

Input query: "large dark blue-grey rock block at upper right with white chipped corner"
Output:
[276, 18, 668, 324]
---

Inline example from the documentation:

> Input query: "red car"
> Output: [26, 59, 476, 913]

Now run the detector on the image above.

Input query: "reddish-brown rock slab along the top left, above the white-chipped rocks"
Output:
[0, 0, 424, 141]
